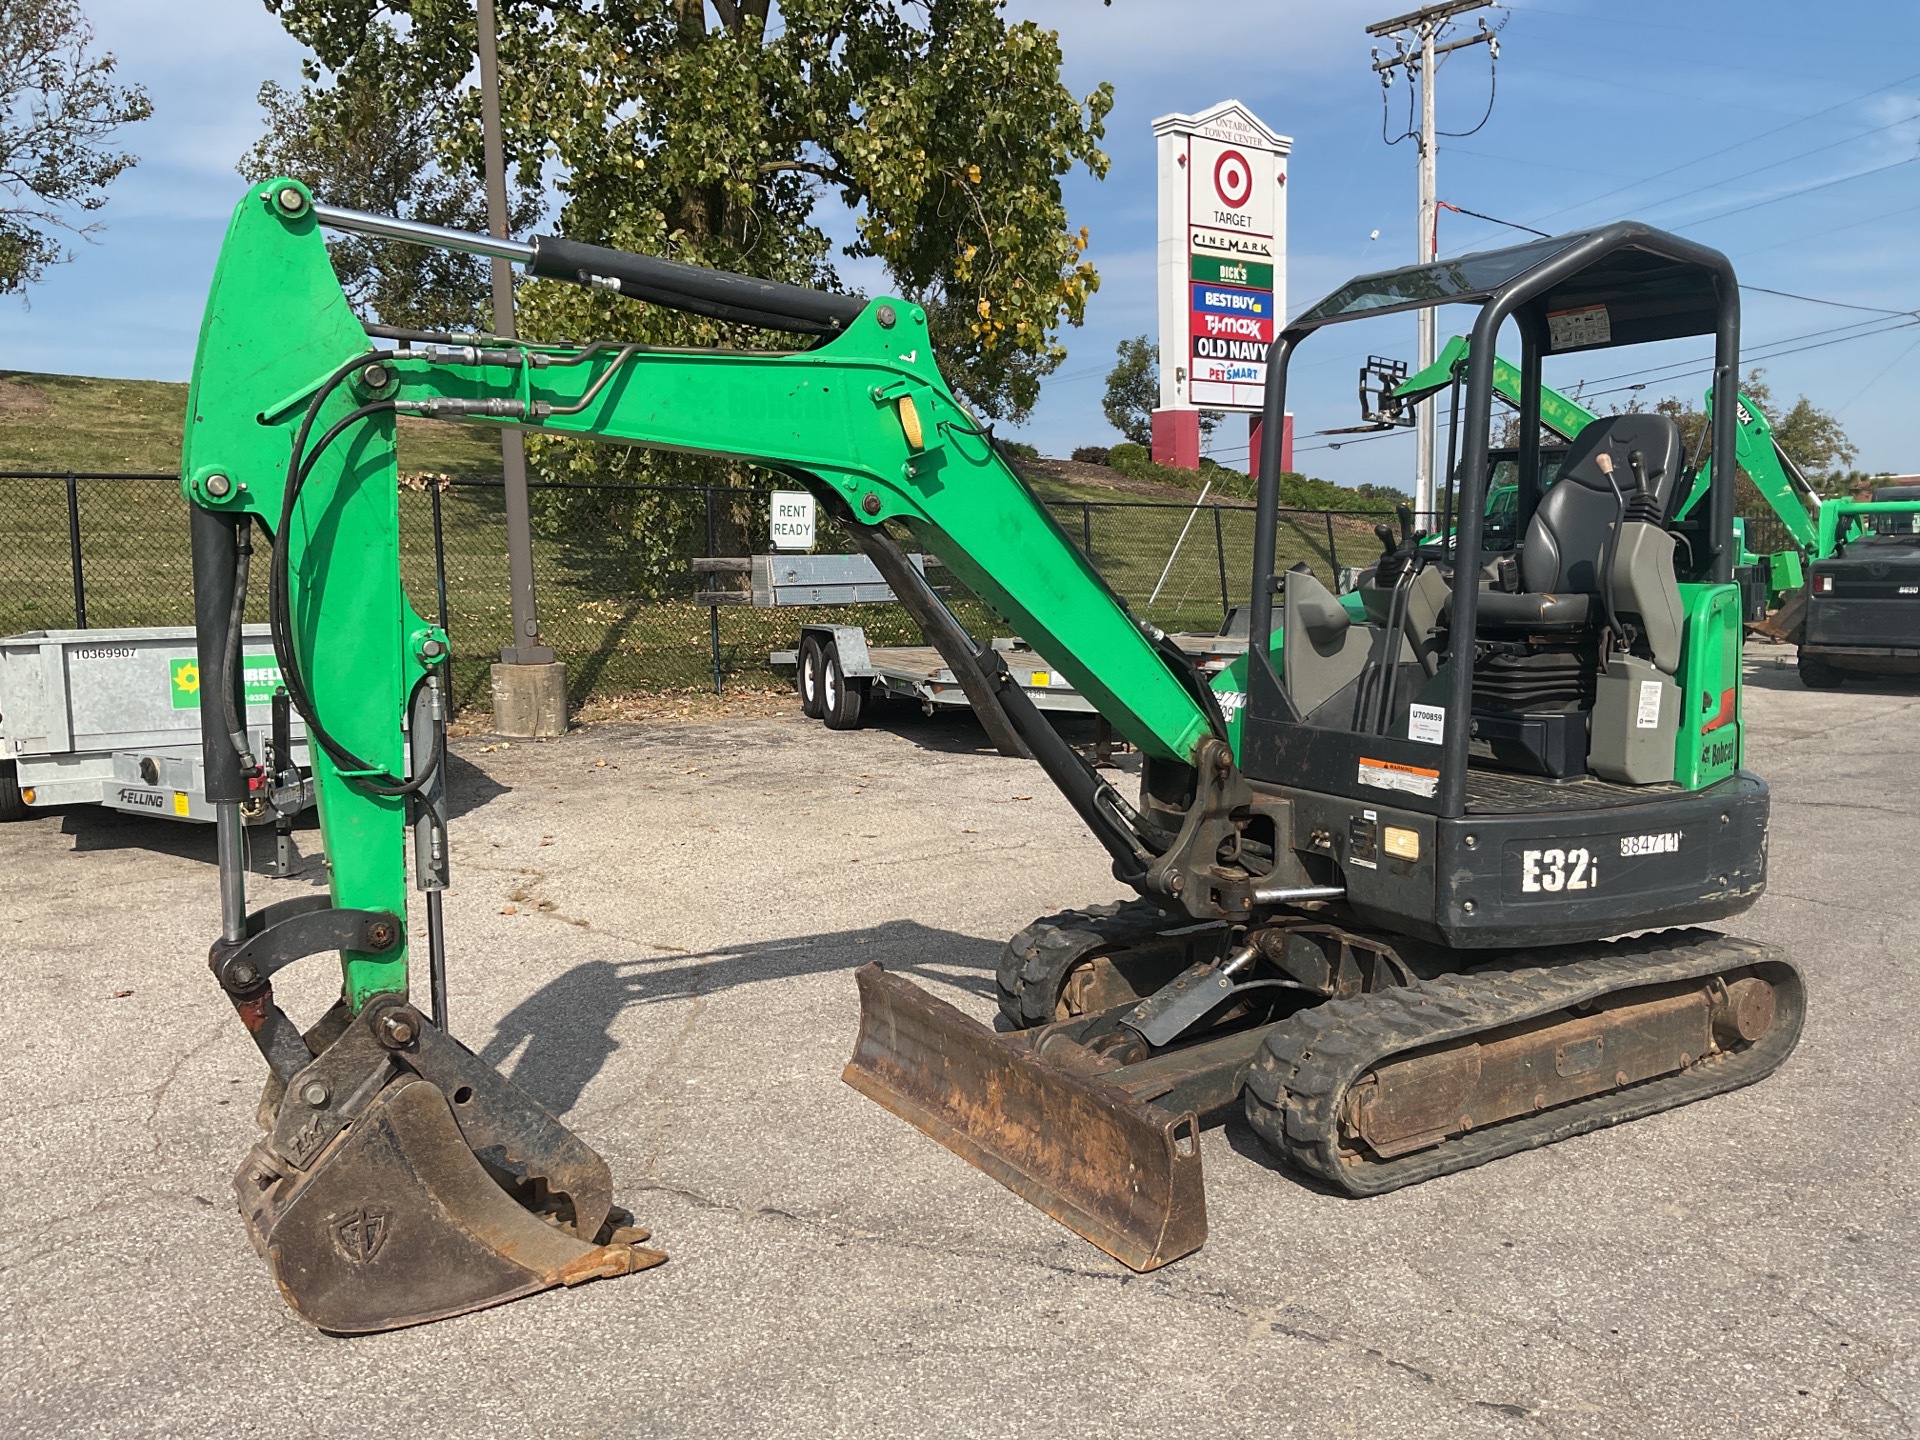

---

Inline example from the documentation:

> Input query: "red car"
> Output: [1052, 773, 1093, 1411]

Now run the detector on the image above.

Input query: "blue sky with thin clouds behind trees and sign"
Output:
[11, 0, 1920, 488]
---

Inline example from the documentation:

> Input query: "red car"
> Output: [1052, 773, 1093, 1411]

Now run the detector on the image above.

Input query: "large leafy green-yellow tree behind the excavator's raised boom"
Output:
[253, 0, 1112, 420]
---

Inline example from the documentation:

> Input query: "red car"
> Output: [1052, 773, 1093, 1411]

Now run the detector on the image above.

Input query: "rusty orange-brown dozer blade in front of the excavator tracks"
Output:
[843, 964, 1206, 1271]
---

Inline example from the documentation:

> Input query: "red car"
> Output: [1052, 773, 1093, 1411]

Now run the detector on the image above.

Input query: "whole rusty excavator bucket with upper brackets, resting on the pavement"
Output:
[234, 1002, 666, 1334]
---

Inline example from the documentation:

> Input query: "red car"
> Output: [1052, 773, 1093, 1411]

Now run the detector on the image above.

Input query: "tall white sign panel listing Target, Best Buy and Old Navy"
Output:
[1154, 100, 1294, 416]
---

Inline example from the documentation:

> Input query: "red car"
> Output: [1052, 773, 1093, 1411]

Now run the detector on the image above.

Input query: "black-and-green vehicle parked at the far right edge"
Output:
[1799, 486, 1920, 689]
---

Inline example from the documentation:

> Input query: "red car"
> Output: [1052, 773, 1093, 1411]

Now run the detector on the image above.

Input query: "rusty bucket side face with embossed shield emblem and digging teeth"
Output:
[234, 1073, 666, 1334]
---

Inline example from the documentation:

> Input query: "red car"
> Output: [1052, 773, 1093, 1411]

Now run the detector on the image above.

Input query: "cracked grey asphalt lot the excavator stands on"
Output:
[0, 651, 1920, 1440]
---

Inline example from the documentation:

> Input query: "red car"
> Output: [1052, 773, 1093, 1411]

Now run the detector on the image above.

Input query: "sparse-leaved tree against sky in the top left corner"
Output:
[0, 0, 154, 294]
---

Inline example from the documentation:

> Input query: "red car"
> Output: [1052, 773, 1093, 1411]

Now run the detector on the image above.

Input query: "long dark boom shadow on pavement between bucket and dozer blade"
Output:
[480, 920, 1000, 1114]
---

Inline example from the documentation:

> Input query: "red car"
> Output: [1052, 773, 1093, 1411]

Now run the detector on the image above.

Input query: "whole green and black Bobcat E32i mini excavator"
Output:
[182, 180, 1803, 1331]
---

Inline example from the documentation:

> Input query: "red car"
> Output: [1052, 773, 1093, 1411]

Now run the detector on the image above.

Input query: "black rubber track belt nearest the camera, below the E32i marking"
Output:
[1246, 929, 1807, 1194]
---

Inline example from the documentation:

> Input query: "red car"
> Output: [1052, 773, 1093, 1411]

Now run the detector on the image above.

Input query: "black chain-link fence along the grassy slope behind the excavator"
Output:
[0, 472, 1379, 707]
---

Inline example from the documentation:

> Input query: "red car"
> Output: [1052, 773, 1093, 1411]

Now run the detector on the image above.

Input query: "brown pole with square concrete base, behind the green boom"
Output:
[474, 0, 566, 737]
